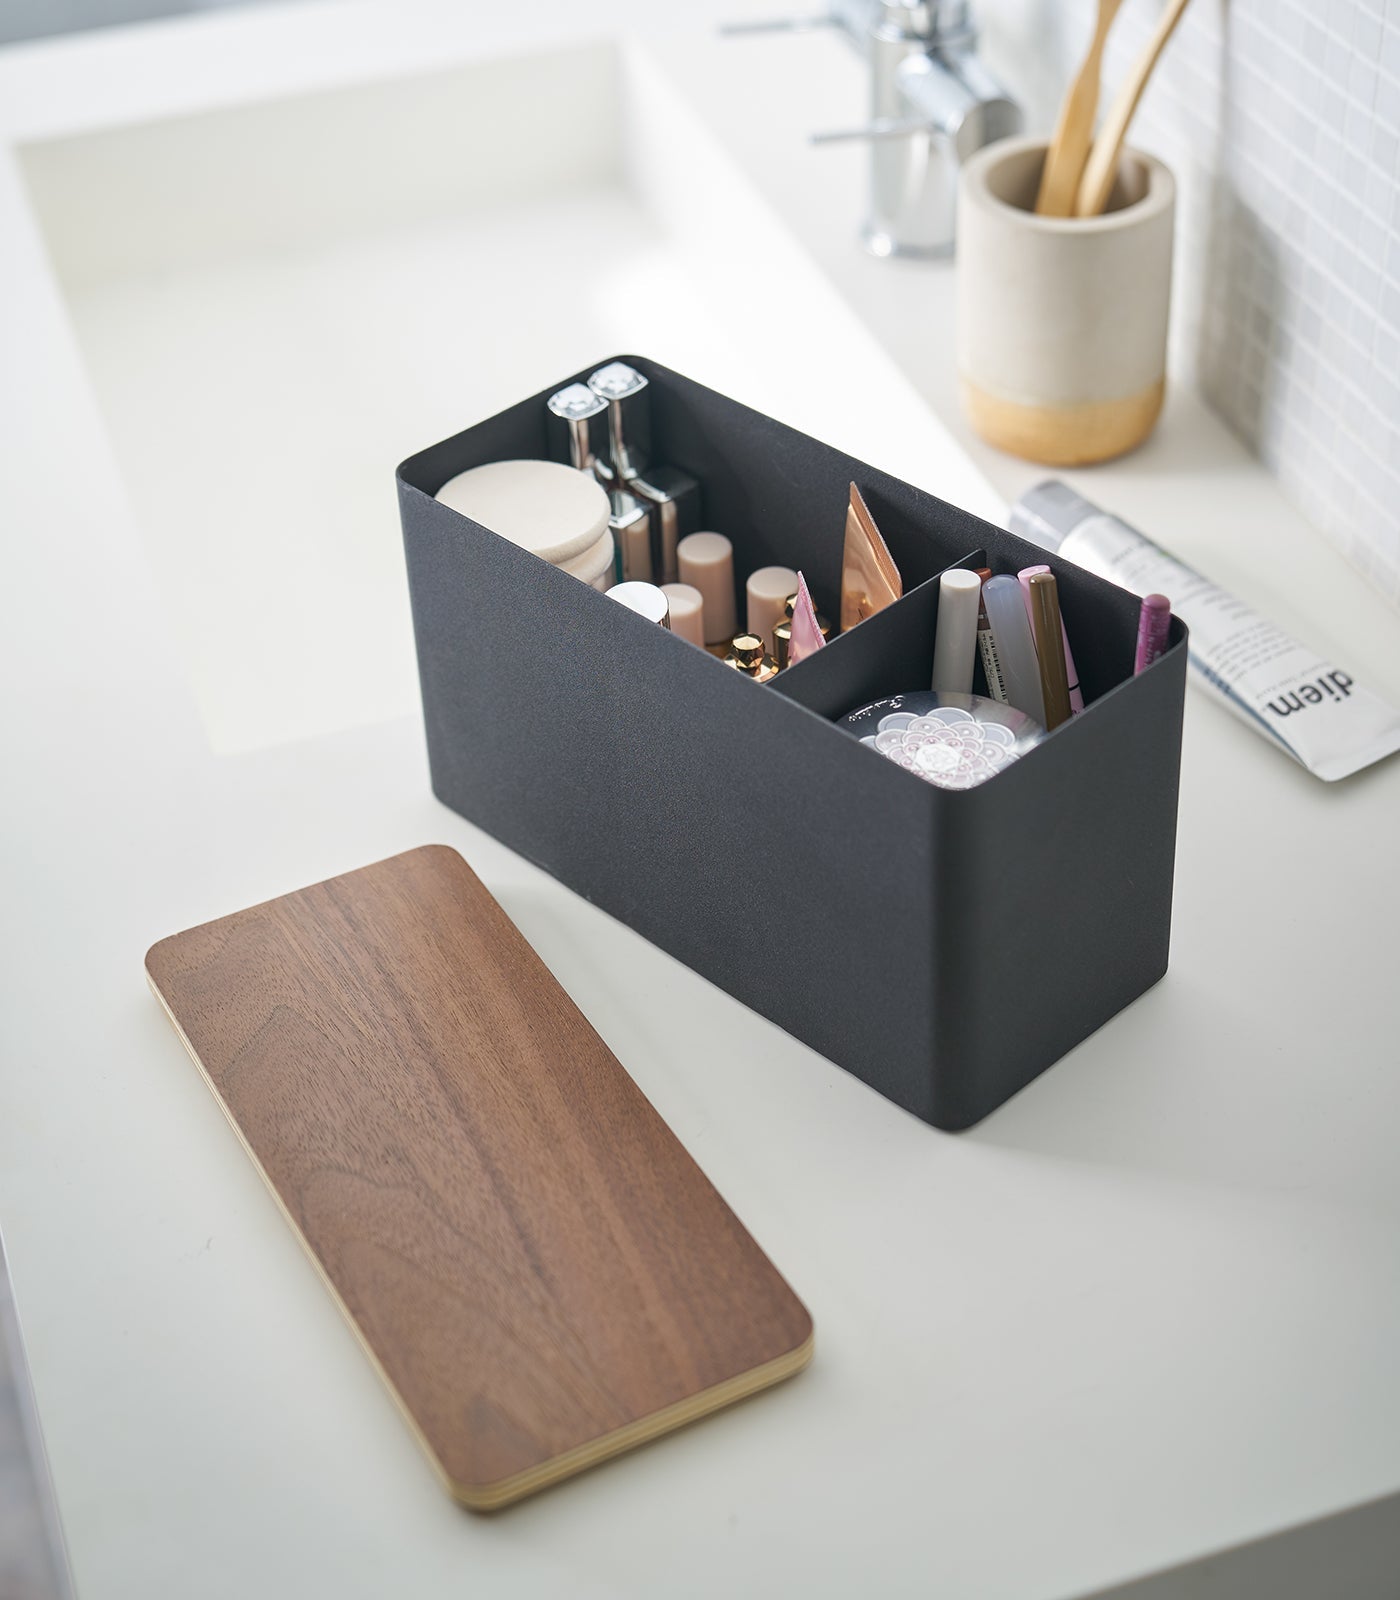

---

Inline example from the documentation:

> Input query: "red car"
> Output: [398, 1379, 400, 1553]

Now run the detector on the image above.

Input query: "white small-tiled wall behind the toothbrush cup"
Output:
[982, 0, 1400, 606]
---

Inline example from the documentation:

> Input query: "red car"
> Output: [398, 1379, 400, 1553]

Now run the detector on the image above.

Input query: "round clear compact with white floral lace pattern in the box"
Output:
[837, 690, 1045, 789]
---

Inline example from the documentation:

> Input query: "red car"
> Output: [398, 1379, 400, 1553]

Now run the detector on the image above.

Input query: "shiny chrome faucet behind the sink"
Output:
[726, 0, 1021, 258]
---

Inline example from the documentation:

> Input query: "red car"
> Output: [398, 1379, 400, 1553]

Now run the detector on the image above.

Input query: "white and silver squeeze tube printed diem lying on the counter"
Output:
[1011, 478, 1400, 782]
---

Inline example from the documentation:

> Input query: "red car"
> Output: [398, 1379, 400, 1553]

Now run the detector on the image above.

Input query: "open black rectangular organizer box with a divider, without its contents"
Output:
[398, 355, 1186, 1130]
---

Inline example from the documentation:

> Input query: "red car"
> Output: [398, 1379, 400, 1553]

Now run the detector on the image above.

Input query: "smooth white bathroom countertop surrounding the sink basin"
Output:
[0, 0, 1400, 1600]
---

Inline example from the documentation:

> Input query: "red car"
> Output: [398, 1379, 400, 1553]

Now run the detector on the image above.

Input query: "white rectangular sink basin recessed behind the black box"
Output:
[22, 42, 997, 752]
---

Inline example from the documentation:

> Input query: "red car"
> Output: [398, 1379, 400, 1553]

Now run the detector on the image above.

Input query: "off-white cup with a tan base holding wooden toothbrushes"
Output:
[958, 139, 1176, 467]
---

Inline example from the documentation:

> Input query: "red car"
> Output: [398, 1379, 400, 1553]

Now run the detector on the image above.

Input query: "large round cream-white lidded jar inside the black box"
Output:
[437, 461, 611, 566]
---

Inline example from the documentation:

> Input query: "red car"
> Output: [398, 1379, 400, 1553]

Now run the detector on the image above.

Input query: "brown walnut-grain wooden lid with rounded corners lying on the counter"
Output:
[146, 846, 811, 1510]
